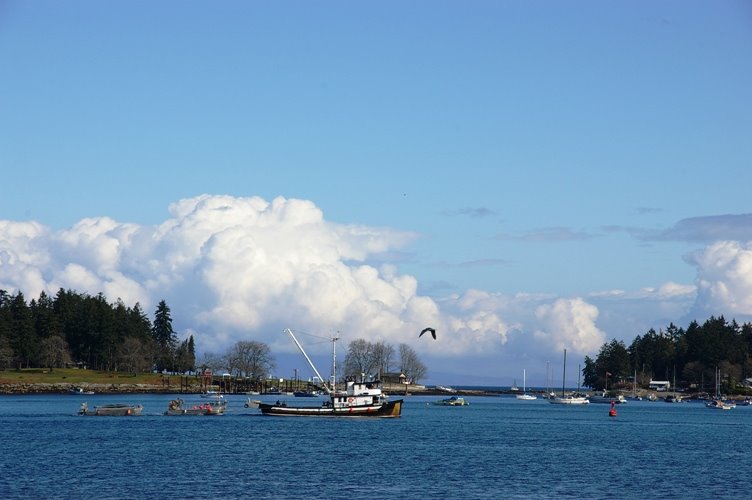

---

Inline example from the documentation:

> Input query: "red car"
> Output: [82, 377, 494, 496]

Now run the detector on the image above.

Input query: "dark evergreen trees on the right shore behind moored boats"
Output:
[582, 316, 752, 392]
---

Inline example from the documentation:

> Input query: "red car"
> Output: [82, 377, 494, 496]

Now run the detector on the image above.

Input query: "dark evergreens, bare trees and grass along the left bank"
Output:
[0, 289, 426, 385]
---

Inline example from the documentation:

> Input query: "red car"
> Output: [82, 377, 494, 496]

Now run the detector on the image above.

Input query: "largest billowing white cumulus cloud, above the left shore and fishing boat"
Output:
[0, 195, 488, 355]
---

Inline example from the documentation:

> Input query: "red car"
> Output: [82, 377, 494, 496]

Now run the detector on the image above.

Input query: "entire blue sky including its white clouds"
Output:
[0, 0, 752, 386]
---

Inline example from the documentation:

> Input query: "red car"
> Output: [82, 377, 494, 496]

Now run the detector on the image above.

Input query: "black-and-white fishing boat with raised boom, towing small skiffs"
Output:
[258, 328, 403, 417]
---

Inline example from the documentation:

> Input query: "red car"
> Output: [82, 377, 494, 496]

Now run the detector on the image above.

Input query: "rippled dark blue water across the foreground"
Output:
[0, 395, 752, 499]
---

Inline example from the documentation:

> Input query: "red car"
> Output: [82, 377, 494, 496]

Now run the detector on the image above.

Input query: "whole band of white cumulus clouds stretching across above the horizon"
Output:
[10, 195, 752, 380]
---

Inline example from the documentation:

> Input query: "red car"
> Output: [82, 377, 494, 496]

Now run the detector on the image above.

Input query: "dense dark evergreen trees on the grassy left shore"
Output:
[0, 288, 195, 373]
